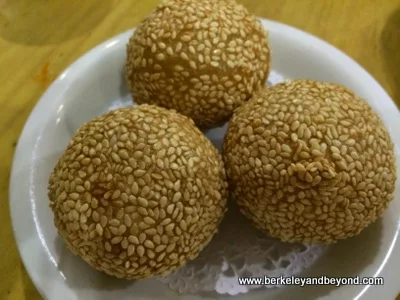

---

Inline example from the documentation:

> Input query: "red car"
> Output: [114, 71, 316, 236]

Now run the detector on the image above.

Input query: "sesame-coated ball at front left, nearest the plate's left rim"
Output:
[48, 105, 227, 279]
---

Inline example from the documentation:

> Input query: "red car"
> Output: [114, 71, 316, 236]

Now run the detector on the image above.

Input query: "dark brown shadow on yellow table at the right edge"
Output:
[381, 8, 400, 106]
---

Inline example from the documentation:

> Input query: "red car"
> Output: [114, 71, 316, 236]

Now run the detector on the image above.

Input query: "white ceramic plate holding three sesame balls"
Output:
[10, 20, 400, 300]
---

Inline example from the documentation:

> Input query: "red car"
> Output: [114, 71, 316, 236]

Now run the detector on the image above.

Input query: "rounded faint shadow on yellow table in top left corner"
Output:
[0, 0, 111, 45]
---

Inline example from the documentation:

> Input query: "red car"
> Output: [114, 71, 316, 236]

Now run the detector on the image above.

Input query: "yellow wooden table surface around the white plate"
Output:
[0, 0, 400, 300]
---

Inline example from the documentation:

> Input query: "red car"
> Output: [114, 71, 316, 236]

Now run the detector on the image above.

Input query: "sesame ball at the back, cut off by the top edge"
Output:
[126, 0, 270, 129]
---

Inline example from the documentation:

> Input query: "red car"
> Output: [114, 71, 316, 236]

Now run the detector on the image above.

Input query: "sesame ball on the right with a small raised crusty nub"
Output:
[224, 80, 396, 243]
